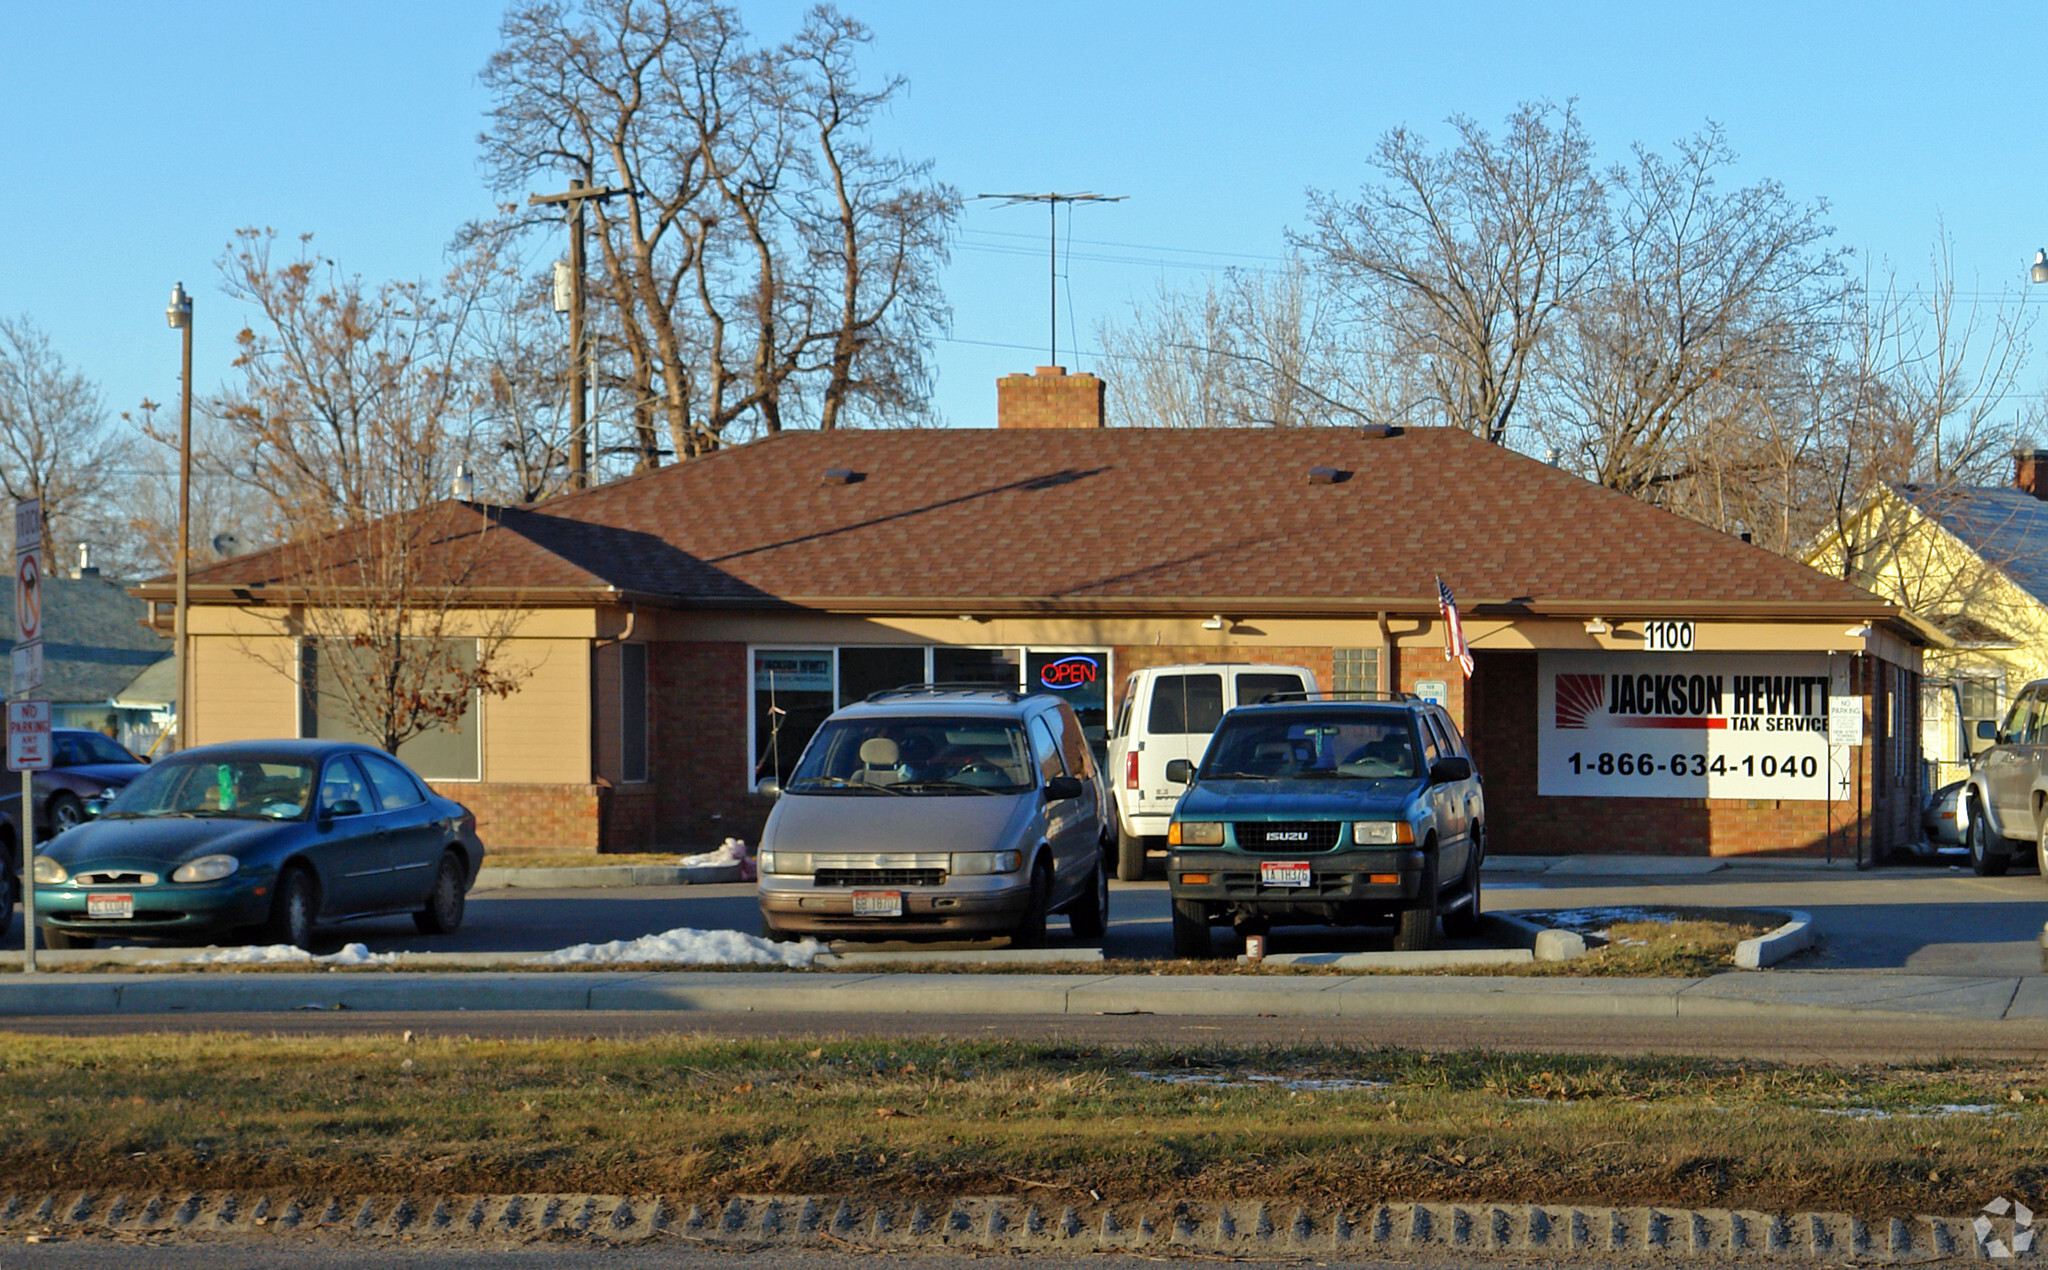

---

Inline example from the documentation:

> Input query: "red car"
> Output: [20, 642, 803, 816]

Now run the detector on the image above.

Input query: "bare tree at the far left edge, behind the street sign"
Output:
[0, 315, 127, 567]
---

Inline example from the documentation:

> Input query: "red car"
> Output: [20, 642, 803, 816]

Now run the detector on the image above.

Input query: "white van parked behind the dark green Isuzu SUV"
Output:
[1104, 662, 1317, 883]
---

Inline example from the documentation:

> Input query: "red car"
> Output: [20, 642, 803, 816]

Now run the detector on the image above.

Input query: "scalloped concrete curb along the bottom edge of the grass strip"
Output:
[0, 1190, 2015, 1264]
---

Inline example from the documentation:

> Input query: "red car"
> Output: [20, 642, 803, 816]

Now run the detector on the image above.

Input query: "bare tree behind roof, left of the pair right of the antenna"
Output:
[1294, 102, 1606, 442]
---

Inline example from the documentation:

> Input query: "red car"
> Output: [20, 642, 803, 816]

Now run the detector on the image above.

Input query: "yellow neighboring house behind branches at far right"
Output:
[1806, 451, 2048, 791]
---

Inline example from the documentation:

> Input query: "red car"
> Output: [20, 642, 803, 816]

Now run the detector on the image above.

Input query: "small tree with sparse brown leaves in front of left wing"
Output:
[209, 231, 526, 752]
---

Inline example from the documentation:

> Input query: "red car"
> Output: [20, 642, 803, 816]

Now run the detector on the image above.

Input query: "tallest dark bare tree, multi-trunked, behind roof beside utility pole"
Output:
[483, 0, 958, 467]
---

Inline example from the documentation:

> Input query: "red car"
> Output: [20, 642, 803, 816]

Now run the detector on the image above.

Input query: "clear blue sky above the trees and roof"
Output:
[0, 0, 2048, 442]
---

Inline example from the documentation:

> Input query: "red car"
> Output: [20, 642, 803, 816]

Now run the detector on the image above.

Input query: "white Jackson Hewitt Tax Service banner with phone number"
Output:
[1536, 651, 1845, 799]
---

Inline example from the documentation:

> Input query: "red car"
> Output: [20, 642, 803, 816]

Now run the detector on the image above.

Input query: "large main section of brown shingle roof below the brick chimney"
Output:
[159, 428, 1888, 615]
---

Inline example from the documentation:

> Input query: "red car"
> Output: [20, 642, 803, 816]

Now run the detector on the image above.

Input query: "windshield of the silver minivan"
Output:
[784, 719, 1036, 795]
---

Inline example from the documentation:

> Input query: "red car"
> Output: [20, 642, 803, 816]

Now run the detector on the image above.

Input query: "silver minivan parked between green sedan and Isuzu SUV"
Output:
[760, 684, 1110, 946]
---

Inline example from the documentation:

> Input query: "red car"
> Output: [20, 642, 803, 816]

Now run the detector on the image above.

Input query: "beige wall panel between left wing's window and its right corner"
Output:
[483, 639, 592, 785]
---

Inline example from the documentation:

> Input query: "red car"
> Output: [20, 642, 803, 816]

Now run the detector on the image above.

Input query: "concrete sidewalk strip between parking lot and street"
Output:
[0, 971, 2048, 1022]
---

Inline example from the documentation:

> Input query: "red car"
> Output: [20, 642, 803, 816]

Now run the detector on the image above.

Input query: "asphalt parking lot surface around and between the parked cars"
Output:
[4, 856, 2048, 975]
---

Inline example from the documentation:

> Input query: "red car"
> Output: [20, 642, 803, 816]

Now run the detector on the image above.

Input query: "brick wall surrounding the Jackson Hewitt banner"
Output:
[1474, 649, 1919, 858]
